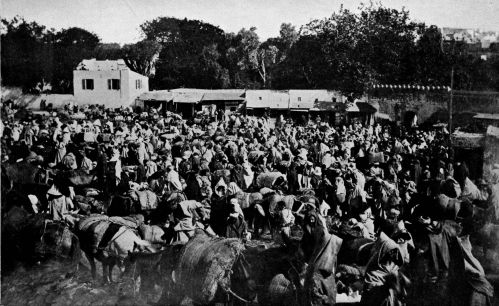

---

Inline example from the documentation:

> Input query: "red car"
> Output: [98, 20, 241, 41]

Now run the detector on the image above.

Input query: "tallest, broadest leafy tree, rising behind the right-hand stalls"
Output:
[290, 3, 418, 97]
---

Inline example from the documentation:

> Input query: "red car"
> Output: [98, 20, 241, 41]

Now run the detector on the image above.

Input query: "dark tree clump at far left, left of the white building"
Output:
[1, 17, 99, 93]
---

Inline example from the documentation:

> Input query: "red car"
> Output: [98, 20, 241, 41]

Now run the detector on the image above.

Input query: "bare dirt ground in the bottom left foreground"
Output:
[1, 233, 499, 306]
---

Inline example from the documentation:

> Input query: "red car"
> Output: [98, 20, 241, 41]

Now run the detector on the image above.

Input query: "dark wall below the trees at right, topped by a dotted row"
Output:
[369, 90, 499, 125]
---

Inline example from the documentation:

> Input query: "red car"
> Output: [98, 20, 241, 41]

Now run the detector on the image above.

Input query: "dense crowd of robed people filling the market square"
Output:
[2, 103, 499, 305]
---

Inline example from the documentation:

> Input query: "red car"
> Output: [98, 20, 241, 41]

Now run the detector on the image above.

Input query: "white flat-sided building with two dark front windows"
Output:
[73, 59, 149, 107]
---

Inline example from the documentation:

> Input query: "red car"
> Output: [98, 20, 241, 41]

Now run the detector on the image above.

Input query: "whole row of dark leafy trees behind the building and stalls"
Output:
[1, 7, 499, 97]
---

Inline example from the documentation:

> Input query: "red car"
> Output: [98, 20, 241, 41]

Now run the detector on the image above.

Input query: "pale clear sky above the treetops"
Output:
[0, 0, 499, 44]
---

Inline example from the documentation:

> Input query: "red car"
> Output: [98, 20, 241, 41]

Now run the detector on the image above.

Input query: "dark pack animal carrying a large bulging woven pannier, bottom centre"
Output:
[168, 230, 302, 305]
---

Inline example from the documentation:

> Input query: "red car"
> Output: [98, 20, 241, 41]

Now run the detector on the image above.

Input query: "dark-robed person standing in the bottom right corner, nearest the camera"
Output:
[408, 207, 494, 306]
